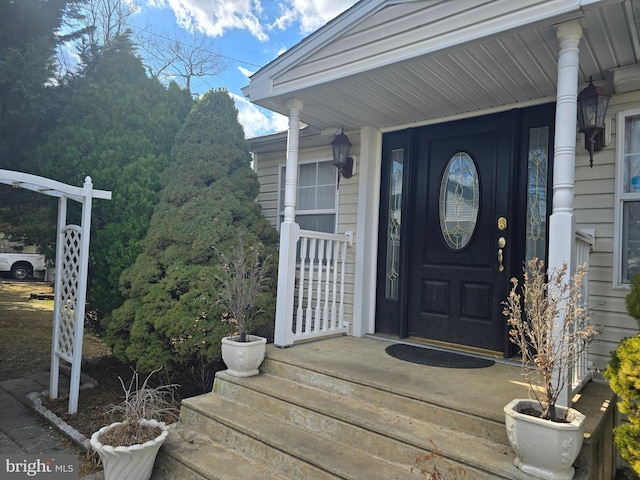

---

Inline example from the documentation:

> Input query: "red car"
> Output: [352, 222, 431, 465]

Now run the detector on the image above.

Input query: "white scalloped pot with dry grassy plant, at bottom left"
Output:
[90, 370, 178, 480]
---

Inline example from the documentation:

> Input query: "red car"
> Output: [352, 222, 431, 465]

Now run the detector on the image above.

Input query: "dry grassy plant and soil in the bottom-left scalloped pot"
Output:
[100, 369, 179, 446]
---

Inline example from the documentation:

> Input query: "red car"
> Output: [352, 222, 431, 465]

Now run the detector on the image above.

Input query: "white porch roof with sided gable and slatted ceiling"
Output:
[243, 0, 640, 132]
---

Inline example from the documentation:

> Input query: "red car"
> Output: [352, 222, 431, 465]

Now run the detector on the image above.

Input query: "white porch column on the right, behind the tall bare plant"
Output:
[548, 21, 582, 406]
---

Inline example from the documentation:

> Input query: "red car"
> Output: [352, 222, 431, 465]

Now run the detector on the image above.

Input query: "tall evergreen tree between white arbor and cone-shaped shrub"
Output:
[28, 47, 193, 313]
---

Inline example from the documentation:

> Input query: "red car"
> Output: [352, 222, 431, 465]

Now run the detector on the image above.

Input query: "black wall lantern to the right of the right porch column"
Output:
[578, 77, 611, 167]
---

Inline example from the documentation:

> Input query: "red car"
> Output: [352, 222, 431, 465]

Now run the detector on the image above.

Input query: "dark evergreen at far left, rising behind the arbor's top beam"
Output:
[0, 0, 82, 238]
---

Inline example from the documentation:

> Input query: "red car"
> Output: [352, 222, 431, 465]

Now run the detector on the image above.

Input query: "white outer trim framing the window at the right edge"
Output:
[613, 108, 640, 290]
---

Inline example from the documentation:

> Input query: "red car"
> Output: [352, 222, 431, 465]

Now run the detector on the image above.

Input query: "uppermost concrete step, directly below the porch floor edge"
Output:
[262, 356, 509, 445]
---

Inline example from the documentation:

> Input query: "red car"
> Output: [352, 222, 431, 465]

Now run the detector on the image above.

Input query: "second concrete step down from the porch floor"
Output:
[206, 372, 529, 479]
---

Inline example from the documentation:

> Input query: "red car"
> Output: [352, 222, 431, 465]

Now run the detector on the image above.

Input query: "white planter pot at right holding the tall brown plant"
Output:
[504, 399, 586, 480]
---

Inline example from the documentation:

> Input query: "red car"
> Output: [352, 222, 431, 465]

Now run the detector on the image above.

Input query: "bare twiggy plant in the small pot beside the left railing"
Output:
[217, 234, 269, 342]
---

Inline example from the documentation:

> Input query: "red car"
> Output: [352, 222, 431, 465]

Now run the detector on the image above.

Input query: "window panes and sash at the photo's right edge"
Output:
[615, 110, 640, 285]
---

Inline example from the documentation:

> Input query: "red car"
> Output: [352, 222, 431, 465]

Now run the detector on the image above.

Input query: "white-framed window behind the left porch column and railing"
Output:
[278, 160, 338, 233]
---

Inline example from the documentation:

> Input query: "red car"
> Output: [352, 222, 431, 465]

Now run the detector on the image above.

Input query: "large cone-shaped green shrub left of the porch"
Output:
[104, 90, 277, 371]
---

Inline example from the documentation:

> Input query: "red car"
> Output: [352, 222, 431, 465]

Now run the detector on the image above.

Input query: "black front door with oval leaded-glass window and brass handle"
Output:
[406, 113, 515, 352]
